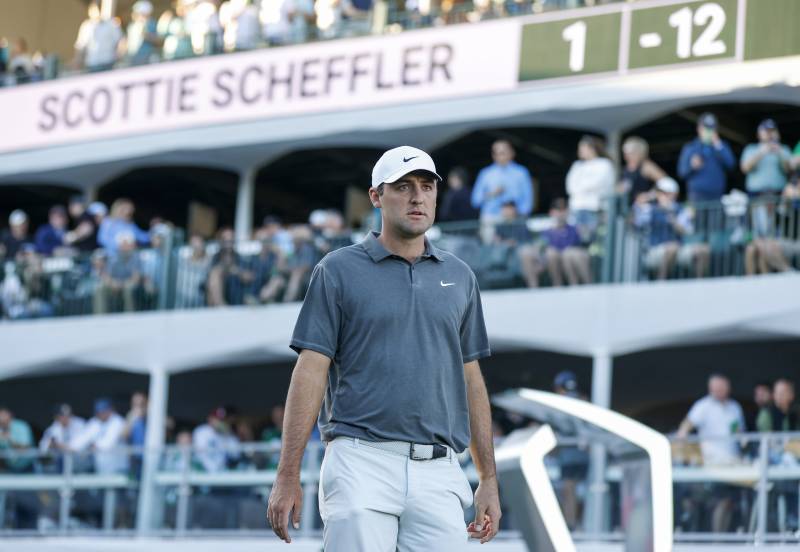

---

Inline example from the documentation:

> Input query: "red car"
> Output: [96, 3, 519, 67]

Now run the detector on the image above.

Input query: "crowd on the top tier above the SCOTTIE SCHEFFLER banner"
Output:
[0, 0, 622, 87]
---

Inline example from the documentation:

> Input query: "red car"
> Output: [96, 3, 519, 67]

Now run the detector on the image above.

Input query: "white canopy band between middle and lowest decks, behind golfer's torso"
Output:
[0, 274, 800, 379]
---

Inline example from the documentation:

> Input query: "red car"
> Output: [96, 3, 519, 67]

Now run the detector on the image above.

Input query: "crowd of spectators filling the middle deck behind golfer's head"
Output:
[0, 113, 800, 319]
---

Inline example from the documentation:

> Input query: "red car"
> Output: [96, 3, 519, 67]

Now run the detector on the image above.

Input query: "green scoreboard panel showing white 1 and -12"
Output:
[519, 0, 800, 81]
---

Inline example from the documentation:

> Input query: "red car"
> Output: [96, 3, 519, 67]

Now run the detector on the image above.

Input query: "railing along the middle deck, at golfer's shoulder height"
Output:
[0, 194, 800, 320]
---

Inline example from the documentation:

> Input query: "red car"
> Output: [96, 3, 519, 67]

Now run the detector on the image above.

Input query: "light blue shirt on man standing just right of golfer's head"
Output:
[472, 161, 533, 218]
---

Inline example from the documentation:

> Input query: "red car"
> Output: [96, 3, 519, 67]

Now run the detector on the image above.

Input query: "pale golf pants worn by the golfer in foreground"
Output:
[319, 437, 472, 552]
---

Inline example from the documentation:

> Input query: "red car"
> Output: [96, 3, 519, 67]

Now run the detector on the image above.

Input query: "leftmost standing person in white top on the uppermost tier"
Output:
[75, 2, 122, 72]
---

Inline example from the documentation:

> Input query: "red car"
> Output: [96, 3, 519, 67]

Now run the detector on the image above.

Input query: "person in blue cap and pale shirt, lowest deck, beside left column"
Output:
[69, 398, 128, 474]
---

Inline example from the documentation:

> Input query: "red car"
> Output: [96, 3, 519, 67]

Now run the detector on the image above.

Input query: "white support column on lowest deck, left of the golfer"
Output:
[136, 366, 169, 535]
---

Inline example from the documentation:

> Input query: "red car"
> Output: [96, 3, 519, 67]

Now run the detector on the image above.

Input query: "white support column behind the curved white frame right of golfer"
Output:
[584, 351, 614, 534]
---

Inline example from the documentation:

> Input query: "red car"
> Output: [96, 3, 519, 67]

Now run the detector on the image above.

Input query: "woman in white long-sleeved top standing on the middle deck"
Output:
[567, 135, 616, 242]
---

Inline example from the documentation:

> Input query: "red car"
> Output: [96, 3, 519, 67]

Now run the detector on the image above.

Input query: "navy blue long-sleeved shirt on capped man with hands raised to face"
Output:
[678, 138, 736, 201]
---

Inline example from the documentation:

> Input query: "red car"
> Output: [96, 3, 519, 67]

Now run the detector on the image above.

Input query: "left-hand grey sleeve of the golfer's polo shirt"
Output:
[289, 262, 342, 359]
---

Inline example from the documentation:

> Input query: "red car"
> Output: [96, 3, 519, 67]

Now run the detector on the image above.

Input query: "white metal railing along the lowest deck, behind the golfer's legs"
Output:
[0, 432, 800, 543]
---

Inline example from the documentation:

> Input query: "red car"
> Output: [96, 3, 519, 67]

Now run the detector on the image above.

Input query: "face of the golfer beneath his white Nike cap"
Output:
[370, 171, 436, 239]
